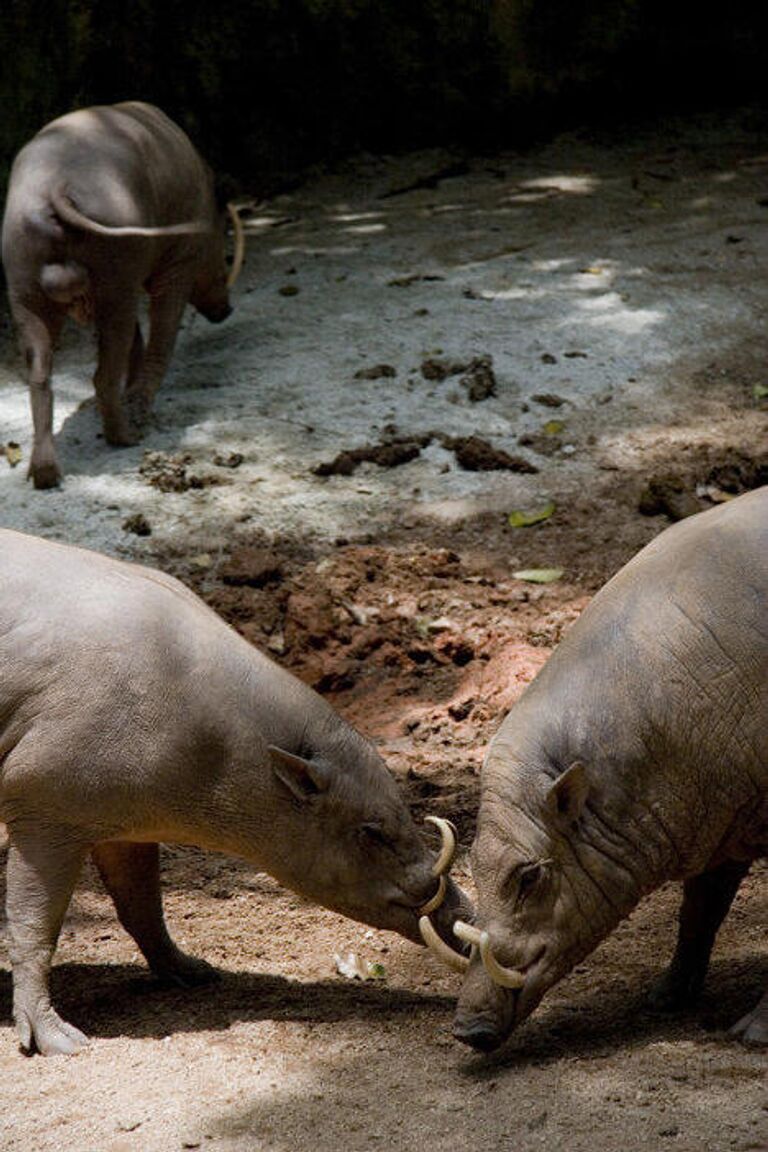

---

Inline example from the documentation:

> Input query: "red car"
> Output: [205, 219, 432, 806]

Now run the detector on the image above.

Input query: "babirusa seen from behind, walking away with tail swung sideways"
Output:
[2, 103, 230, 488]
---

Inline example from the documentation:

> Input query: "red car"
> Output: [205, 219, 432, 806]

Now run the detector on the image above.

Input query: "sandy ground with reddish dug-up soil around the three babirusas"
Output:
[0, 114, 768, 1152]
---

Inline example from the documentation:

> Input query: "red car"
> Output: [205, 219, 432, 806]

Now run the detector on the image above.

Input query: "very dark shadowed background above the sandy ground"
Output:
[0, 0, 768, 191]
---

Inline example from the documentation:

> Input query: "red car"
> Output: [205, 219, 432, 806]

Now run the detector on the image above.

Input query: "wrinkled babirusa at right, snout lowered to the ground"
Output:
[454, 488, 768, 1051]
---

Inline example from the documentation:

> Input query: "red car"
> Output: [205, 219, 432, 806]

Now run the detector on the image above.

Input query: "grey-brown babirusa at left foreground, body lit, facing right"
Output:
[0, 531, 472, 1054]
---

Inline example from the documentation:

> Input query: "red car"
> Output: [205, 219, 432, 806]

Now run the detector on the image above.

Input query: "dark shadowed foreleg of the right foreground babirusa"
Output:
[651, 861, 750, 1011]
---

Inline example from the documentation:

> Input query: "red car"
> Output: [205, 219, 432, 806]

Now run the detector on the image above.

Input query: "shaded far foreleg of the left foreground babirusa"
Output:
[91, 840, 216, 987]
